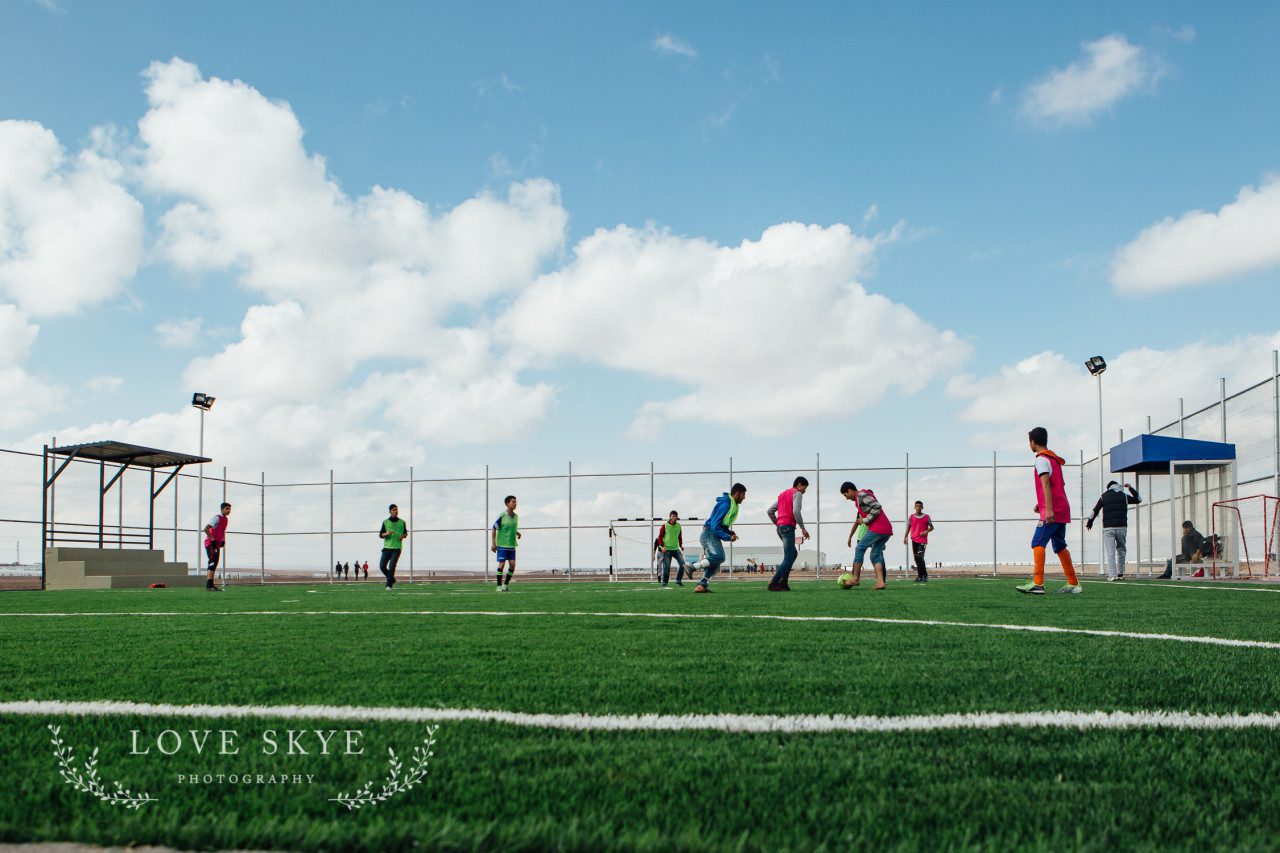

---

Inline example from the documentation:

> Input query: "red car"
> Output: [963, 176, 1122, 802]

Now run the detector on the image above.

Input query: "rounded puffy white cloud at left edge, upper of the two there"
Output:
[0, 120, 143, 316]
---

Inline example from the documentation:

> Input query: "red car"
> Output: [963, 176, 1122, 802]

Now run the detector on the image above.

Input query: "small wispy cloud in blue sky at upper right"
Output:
[1021, 33, 1166, 127]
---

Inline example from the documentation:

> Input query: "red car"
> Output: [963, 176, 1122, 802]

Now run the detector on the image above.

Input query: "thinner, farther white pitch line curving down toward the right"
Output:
[0, 610, 1280, 649]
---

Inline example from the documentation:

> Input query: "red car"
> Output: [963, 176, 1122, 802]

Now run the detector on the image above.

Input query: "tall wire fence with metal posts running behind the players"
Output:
[0, 353, 1280, 587]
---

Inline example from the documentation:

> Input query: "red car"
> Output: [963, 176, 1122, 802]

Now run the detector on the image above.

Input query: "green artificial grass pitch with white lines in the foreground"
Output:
[0, 579, 1280, 850]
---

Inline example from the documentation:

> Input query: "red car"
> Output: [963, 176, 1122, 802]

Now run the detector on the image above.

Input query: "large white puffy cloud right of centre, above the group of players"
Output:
[498, 223, 969, 438]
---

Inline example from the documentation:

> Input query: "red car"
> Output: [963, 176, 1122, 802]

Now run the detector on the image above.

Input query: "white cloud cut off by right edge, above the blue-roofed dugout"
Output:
[1111, 177, 1280, 293]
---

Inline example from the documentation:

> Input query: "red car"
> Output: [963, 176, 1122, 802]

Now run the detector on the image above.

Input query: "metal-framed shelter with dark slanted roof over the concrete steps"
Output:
[40, 441, 214, 589]
